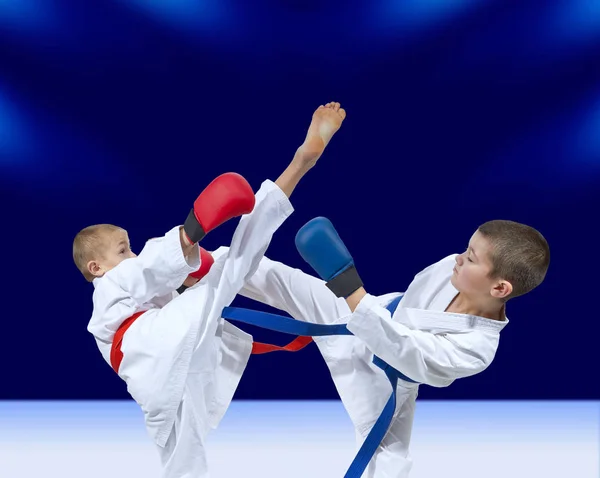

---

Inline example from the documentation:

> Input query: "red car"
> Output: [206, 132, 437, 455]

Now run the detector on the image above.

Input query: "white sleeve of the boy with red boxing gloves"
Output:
[106, 227, 200, 305]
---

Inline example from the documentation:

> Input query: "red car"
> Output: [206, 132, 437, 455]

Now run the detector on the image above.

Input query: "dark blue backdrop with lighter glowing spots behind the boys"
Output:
[0, 0, 600, 399]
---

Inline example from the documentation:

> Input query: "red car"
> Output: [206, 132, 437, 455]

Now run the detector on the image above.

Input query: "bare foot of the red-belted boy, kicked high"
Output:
[297, 102, 346, 167]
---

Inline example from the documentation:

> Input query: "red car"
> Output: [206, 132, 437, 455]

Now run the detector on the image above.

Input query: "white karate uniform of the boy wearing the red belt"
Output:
[88, 181, 293, 478]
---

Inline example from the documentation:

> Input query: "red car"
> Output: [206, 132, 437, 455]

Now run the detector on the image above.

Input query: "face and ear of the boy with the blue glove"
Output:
[450, 231, 512, 298]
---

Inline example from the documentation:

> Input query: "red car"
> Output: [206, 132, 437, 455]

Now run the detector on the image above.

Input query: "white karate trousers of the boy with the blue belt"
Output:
[240, 258, 418, 478]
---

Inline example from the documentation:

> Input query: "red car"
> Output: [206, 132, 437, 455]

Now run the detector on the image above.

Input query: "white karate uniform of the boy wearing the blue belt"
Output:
[240, 255, 508, 478]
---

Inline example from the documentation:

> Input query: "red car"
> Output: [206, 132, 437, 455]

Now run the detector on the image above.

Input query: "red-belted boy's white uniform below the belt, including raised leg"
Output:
[120, 181, 293, 478]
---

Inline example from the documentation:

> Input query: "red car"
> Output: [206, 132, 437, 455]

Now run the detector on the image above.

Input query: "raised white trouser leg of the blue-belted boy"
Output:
[213, 247, 350, 324]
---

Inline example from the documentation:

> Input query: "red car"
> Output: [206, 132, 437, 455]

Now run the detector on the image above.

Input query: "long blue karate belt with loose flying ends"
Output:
[221, 296, 417, 478]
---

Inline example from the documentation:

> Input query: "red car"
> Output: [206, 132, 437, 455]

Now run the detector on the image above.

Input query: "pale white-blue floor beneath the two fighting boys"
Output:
[0, 401, 600, 478]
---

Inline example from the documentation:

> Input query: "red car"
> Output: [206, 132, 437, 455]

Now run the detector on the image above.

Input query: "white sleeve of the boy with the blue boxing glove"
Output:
[347, 294, 497, 387]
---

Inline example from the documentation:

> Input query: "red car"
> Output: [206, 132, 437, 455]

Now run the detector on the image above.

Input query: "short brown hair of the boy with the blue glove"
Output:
[478, 220, 550, 299]
